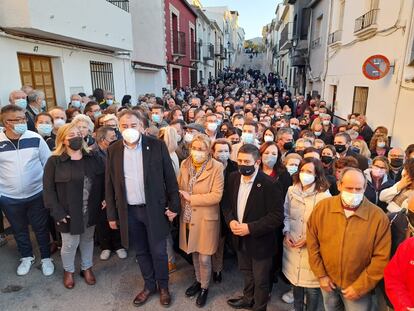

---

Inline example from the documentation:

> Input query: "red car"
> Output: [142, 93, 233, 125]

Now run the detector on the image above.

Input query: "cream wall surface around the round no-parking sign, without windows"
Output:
[324, 0, 411, 146]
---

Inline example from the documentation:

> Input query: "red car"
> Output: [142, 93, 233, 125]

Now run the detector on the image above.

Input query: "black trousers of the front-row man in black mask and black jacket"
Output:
[237, 251, 272, 311]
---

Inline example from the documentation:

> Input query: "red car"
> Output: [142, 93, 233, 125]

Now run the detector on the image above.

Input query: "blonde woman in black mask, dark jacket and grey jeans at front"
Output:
[43, 123, 105, 289]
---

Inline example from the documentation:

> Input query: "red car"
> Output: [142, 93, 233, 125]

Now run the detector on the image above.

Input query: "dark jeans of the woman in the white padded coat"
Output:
[293, 286, 324, 311]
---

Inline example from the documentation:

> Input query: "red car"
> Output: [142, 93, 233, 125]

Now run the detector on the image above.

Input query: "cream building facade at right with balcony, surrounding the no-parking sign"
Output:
[322, 0, 414, 148]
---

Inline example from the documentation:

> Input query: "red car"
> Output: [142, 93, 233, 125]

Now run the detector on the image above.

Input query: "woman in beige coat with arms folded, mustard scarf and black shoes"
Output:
[178, 134, 224, 307]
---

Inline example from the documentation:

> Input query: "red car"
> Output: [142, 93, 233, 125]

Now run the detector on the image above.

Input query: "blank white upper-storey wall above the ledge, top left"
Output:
[0, 0, 132, 50]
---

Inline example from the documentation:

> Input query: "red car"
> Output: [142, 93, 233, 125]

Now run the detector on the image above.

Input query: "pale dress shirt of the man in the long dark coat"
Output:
[124, 140, 145, 205]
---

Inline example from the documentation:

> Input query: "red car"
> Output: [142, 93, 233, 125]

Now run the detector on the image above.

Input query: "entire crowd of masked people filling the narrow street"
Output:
[0, 68, 414, 311]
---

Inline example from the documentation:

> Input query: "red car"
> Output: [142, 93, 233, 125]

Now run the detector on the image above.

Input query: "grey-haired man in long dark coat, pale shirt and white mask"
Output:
[105, 110, 180, 306]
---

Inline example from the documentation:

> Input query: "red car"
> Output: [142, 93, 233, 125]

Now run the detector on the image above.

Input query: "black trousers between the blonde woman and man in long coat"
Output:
[96, 209, 123, 251]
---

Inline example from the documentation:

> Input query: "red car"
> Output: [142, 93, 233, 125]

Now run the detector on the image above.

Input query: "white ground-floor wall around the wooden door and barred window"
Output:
[0, 36, 135, 105]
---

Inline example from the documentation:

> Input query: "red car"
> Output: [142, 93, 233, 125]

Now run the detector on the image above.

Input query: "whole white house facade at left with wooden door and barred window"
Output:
[0, 0, 135, 107]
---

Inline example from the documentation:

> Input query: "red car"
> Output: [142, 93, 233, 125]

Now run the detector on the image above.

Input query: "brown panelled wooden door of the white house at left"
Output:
[17, 54, 56, 108]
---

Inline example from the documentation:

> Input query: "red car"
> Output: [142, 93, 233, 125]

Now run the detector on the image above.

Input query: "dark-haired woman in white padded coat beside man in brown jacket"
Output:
[282, 158, 331, 311]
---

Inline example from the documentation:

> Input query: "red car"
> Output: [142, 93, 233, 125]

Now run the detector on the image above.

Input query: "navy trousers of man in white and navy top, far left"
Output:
[0, 192, 50, 259]
